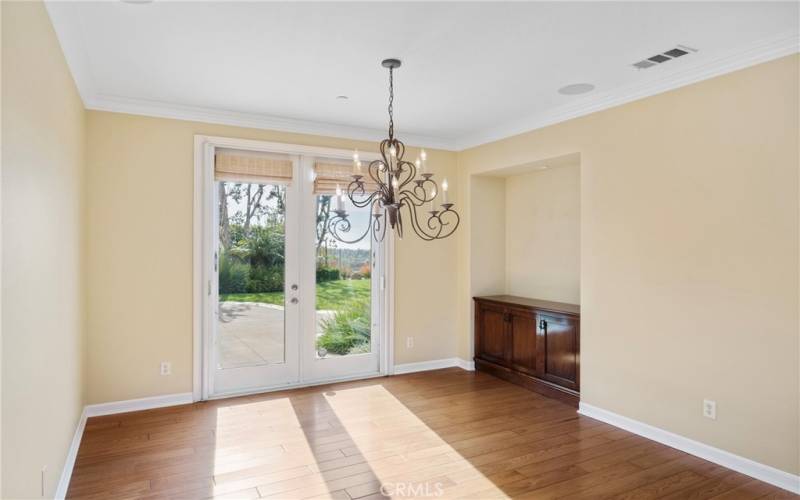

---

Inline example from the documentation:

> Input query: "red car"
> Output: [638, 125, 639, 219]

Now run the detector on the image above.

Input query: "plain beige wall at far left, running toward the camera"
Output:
[1, 2, 86, 498]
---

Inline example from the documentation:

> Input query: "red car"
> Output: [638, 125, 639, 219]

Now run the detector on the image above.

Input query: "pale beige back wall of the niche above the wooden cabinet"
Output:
[505, 165, 581, 304]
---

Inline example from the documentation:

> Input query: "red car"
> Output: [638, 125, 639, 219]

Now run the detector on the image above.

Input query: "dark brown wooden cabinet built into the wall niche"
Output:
[475, 295, 580, 405]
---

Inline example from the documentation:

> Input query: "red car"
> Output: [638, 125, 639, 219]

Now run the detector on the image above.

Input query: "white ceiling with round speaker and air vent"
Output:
[47, 0, 798, 149]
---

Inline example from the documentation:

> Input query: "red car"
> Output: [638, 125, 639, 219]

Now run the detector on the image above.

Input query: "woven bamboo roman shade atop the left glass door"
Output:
[214, 150, 292, 184]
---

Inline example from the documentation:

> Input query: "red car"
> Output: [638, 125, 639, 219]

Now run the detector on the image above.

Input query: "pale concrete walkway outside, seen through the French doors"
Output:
[217, 302, 334, 370]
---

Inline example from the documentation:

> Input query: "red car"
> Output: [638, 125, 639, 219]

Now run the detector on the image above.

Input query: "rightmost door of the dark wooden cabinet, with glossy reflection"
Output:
[536, 313, 580, 391]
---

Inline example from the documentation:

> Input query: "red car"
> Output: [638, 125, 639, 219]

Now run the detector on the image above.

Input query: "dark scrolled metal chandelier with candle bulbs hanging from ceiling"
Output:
[328, 59, 461, 243]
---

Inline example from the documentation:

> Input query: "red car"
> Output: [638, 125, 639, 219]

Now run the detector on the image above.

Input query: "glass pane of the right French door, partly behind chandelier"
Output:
[316, 195, 373, 358]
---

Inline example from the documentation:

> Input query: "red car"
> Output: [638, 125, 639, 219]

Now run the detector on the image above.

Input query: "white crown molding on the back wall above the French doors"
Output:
[84, 94, 455, 150]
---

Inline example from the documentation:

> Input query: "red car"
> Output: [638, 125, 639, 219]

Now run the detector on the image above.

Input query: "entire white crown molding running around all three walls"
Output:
[50, 0, 800, 155]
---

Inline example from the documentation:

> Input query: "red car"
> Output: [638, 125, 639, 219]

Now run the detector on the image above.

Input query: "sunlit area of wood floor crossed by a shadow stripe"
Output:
[202, 384, 508, 498]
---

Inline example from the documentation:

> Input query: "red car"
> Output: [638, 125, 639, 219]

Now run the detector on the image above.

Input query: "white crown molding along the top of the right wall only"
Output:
[454, 32, 800, 151]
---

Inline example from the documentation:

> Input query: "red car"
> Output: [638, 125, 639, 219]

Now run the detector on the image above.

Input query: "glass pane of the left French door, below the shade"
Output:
[216, 182, 286, 370]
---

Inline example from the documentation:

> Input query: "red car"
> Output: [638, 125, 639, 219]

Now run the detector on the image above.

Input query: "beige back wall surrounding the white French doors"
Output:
[87, 111, 460, 403]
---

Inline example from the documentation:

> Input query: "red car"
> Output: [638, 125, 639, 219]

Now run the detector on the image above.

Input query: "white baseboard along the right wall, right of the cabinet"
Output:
[578, 402, 800, 494]
